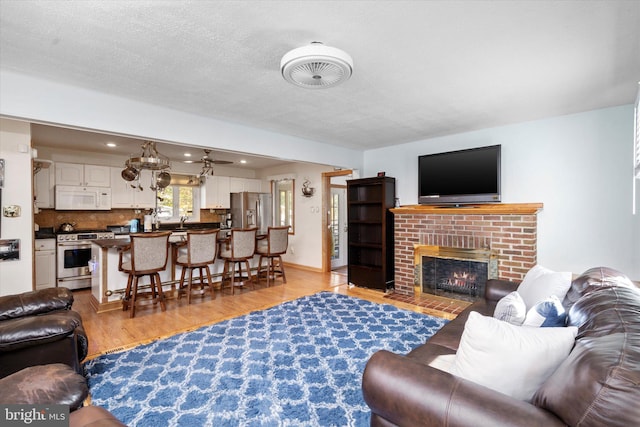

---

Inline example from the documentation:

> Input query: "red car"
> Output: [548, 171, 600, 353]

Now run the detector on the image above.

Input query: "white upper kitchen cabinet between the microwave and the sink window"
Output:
[111, 167, 156, 209]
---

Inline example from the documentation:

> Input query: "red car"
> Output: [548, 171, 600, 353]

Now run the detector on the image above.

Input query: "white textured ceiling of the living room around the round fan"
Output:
[0, 0, 640, 154]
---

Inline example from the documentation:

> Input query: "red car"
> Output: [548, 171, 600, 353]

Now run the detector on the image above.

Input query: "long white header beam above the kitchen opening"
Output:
[0, 70, 362, 168]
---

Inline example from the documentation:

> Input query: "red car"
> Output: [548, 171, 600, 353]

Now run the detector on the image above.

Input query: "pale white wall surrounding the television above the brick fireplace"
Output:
[363, 105, 640, 280]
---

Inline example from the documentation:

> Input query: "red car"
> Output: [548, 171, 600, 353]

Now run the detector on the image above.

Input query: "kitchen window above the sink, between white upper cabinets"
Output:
[156, 185, 200, 222]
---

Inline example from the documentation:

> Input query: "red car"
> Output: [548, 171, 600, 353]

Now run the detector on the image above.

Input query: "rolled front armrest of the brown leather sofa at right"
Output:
[362, 350, 565, 427]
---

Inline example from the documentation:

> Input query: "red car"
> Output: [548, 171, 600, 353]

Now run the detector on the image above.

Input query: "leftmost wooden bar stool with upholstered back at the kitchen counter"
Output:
[118, 231, 171, 317]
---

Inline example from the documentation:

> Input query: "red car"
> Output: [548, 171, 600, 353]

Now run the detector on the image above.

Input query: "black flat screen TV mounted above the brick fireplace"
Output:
[418, 145, 500, 206]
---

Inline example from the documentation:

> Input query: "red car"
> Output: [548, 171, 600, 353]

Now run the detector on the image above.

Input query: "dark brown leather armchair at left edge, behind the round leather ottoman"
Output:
[0, 288, 88, 378]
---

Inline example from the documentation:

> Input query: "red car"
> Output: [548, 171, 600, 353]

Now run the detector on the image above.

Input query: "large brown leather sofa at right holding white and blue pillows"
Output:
[362, 267, 640, 427]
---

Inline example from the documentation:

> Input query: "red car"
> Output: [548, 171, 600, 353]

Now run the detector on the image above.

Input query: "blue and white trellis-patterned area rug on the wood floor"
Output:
[85, 292, 447, 427]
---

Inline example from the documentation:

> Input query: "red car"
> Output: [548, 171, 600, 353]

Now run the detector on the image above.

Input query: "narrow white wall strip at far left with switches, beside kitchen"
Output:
[0, 119, 33, 295]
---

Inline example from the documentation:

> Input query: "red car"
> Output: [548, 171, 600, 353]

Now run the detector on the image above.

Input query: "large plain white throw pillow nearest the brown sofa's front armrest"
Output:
[450, 311, 578, 401]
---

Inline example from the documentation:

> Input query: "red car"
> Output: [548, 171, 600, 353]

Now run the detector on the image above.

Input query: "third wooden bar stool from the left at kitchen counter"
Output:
[220, 228, 258, 295]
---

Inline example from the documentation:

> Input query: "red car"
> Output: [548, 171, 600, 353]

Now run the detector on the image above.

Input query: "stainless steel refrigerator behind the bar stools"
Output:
[231, 191, 273, 234]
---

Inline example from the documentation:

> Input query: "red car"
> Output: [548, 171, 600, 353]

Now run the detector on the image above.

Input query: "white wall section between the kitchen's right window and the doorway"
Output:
[259, 163, 333, 270]
